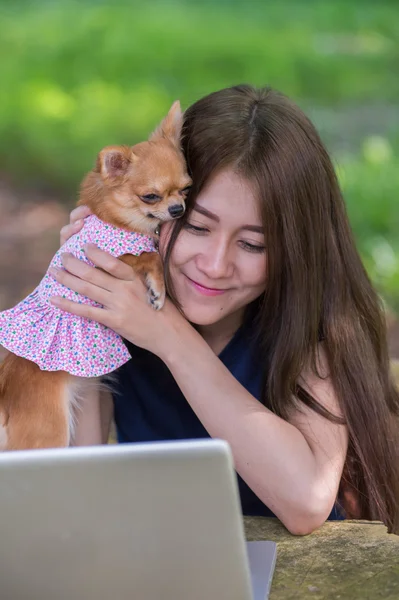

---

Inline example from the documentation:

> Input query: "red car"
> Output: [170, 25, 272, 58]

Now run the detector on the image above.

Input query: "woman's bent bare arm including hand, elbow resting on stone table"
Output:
[48, 246, 347, 534]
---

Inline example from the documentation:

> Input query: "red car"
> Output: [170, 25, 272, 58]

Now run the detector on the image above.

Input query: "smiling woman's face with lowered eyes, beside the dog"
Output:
[160, 169, 266, 326]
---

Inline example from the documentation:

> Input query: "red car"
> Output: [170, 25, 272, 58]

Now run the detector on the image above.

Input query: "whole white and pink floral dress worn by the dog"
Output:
[0, 215, 156, 377]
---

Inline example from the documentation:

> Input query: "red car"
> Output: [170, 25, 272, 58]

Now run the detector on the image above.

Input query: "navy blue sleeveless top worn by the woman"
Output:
[113, 314, 342, 519]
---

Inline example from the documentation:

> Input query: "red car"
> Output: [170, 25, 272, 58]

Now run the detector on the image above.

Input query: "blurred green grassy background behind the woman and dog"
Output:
[0, 0, 399, 357]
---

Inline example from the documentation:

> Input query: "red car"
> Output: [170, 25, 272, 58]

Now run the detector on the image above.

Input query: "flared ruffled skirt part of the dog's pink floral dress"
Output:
[0, 292, 130, 377]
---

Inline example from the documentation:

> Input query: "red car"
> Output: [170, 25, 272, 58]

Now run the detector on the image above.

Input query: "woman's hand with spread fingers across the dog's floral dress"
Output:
[50, 244, 188, 356]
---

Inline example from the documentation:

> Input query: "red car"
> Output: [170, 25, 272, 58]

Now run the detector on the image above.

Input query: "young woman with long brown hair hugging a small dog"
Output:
[54, 85, 399, 534]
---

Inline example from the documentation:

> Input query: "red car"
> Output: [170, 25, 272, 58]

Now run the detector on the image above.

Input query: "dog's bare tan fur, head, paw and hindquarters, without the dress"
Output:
[0, 102, 191, 450]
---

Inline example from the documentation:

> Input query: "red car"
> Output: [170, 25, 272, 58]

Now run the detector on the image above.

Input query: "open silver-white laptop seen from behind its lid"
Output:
[0, 440, 276, 600]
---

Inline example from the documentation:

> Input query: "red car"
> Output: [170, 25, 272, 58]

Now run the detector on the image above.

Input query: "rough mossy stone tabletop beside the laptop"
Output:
[245, 517, 399, 600]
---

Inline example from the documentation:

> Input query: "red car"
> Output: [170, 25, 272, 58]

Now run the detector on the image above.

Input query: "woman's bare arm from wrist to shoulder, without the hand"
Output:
[160, 318, 347, 534]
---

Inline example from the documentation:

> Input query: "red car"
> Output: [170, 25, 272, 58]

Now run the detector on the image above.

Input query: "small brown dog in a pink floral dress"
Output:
[0, 102, 191, 450]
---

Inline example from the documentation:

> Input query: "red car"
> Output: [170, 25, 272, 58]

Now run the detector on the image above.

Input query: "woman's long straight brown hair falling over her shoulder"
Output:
[165, 85, 399, 533]
